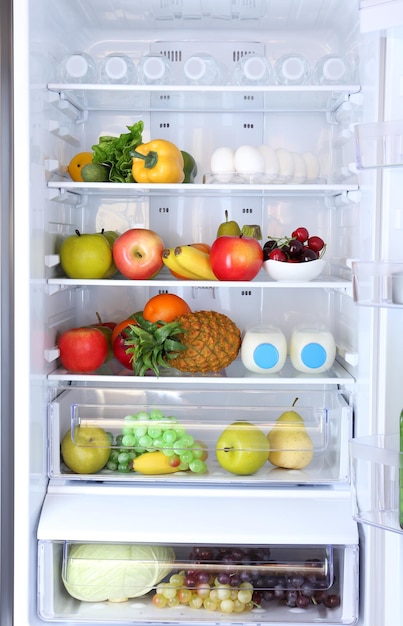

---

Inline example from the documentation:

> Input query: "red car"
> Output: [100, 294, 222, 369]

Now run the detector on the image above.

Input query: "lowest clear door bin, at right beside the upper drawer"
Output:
[350, 434, 403, 533]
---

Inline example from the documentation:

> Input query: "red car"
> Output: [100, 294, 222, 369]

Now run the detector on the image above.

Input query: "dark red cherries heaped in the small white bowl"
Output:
[263, 226, 326, 263]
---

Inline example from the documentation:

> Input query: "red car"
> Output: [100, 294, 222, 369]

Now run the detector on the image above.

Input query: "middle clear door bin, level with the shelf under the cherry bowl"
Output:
[352, 261, 403, 307]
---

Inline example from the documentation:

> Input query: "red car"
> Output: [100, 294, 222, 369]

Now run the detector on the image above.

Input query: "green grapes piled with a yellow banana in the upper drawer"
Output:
[106, 409, 207, 474]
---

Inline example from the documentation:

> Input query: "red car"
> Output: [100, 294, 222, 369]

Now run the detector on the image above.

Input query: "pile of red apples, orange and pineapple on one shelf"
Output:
[58, 293, 241, 376]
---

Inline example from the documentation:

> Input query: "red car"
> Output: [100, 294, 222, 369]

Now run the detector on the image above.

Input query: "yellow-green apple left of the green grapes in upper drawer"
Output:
[61, 426, 111, 474]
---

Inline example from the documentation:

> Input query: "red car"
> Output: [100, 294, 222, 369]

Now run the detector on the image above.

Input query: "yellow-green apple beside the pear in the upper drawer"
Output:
[216, 421, 270, 476]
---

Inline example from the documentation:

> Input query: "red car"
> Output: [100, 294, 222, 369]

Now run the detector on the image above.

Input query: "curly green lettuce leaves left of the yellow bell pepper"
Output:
[92, 121, 144, 183]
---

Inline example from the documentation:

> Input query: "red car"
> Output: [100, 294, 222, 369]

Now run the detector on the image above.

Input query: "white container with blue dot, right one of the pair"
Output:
[289, 328, 336, 374]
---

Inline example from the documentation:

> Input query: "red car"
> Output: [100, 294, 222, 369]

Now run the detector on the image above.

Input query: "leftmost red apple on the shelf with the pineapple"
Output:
[58, 326, 108, 372]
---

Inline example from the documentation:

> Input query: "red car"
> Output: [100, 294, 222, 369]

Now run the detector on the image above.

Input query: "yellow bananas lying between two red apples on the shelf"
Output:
[162, 244, 217, 280]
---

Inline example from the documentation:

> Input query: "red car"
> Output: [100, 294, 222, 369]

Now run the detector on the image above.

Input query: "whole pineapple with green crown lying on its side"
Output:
[126, 311, 241, 376]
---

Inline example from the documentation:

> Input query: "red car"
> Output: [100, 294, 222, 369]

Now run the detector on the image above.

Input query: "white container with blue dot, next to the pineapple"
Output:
[241, 326, 287, 374]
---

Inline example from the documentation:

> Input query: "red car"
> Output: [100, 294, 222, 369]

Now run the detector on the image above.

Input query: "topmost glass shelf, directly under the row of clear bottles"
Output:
[48, 83, 360, 113]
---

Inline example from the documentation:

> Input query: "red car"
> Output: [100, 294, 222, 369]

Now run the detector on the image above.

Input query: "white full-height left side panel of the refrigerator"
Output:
[12, 0, 48, 626]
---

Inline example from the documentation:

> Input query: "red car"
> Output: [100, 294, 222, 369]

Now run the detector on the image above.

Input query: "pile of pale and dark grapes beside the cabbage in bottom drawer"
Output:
[152, 547, 340, 613]
